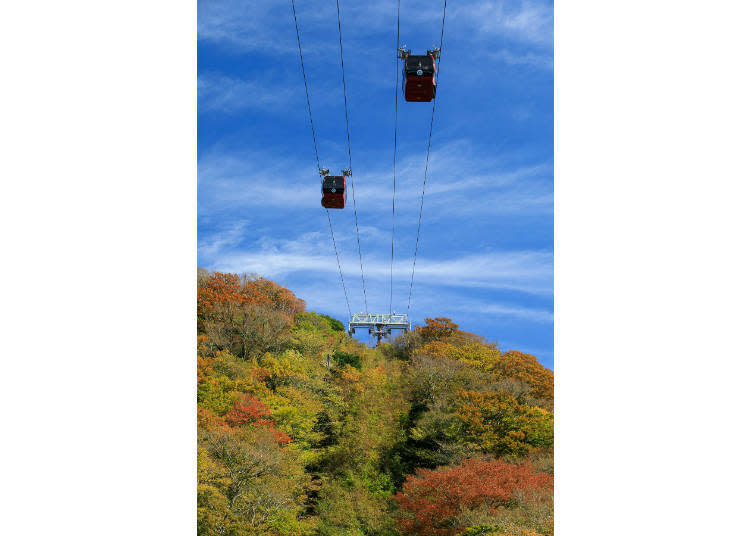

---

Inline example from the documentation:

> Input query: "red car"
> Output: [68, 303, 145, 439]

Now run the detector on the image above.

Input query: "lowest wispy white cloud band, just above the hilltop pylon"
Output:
[199, 225, 553, 325]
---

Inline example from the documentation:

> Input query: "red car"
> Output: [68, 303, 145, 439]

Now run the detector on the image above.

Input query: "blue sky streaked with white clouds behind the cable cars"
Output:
[198, 0, 553, 368]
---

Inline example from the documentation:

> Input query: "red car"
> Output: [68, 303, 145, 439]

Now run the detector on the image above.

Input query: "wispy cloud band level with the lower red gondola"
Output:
[198, 141, 552, 217]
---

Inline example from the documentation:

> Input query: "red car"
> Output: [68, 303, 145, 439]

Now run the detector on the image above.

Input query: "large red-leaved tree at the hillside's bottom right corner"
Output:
[395, 459, 553, 536]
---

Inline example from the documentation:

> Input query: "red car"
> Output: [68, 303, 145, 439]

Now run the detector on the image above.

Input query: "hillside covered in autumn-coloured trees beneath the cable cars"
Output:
[197, 270, 553, 536]
